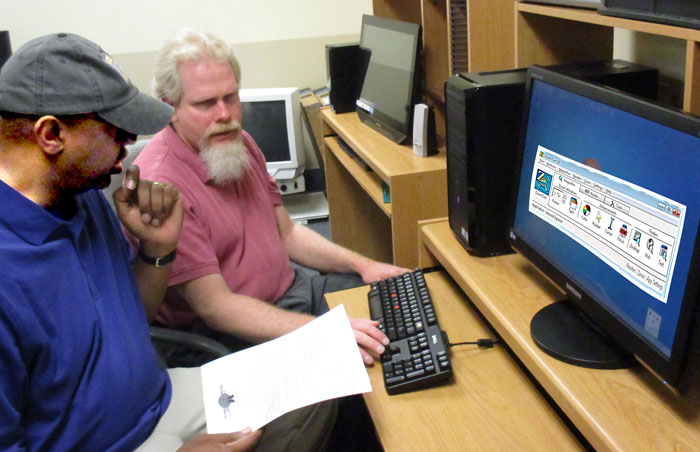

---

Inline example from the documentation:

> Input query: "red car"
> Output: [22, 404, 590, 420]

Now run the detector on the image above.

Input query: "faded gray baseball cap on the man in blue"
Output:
[0, 33, 174, 135]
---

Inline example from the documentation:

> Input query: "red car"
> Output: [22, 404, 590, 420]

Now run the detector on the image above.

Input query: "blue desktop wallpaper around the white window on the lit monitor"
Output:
[514, 80, 700, 356]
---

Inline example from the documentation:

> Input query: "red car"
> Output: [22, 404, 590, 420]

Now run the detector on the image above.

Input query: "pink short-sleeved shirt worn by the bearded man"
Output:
[134, 127, 294, 327]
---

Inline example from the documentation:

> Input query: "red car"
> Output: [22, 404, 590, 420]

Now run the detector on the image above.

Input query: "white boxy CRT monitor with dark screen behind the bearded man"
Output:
[239, 88, 304, 182]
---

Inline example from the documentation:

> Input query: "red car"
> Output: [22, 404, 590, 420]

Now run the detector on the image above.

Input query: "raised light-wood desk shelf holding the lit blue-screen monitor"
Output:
[420, 219, 700, 452]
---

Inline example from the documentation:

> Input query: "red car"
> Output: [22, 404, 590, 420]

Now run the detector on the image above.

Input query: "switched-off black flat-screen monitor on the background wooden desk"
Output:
[356, 14, 422, 143]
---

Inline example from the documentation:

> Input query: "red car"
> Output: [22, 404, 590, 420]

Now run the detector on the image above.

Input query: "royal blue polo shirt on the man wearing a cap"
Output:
[0, 181, 171, 451]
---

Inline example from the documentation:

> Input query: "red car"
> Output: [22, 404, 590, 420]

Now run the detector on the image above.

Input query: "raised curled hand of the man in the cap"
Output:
[112, 165, 183, 257]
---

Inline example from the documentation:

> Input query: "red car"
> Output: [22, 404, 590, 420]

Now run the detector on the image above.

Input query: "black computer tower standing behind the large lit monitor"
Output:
[445, 60, 658, 256]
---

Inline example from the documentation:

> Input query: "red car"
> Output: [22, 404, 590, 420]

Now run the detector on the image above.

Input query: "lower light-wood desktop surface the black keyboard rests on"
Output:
[326, 272, 583, 452]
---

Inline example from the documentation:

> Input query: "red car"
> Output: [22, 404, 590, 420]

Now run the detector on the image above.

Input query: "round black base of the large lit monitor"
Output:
[530, 299, 637, 369]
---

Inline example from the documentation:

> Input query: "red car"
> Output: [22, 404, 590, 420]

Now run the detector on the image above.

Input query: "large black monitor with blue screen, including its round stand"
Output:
[510, 67, 700, 386]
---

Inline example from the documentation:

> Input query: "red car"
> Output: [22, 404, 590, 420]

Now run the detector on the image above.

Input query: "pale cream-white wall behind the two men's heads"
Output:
[0, 0, 372, 168]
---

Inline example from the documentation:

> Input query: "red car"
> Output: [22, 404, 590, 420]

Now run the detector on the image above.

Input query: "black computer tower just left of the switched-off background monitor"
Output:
[326, 43, 370, 113]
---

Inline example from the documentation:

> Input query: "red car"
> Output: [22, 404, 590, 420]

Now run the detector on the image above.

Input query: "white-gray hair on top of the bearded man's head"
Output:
[152, 29, 241, 104]
